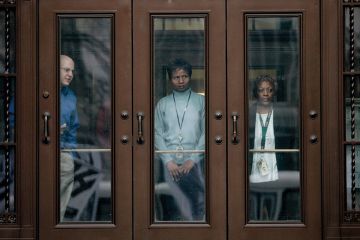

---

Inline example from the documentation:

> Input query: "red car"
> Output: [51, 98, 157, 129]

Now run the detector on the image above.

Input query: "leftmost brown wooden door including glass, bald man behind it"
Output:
[38, 0, 132, 240]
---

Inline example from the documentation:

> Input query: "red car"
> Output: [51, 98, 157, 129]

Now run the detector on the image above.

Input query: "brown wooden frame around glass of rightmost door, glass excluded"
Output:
[227, 0, 322, 239]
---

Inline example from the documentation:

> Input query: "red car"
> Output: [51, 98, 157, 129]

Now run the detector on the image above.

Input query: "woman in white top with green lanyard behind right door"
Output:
[249, 75, 299, 183]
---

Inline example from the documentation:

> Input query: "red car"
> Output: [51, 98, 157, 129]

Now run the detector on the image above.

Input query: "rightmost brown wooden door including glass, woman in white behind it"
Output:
[227, 0, 321, 240]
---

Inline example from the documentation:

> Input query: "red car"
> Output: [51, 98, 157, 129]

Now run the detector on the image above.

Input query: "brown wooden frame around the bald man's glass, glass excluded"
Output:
[38, 0, 132, 239]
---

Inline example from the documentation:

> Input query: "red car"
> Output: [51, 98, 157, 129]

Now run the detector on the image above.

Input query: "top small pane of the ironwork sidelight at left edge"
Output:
[0, 8, 16, 73]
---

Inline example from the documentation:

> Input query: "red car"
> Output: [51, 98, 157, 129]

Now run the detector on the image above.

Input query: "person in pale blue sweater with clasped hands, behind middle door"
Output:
[154, 59, 205, 221]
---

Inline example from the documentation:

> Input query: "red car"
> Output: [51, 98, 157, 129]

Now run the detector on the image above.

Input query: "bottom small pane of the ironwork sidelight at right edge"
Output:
[346, 146, 360, 211]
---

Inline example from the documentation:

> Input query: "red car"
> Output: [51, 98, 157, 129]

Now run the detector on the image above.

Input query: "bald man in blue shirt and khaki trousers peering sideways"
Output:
[60, 55, 79, 221]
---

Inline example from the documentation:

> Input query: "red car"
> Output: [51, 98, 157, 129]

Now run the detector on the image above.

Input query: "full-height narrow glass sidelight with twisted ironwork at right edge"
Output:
[343, 6, 360, 216]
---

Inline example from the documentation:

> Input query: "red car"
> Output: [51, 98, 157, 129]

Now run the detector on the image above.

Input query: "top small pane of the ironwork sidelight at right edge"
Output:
[344, 7, 360, 72]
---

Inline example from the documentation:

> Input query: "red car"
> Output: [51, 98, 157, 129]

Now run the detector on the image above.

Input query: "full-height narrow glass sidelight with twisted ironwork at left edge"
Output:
[0, 1, 16, 224]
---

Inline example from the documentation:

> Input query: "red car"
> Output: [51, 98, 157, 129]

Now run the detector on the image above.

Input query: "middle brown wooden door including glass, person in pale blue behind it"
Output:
[133, 0, 226, 240]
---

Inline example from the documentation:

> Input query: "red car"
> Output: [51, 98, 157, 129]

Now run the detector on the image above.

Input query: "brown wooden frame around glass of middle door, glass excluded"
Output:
[133, 0, 226, 240]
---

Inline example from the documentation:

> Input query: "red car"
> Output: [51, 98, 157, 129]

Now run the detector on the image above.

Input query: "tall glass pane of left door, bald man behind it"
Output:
[59, 15, 113, 222]
